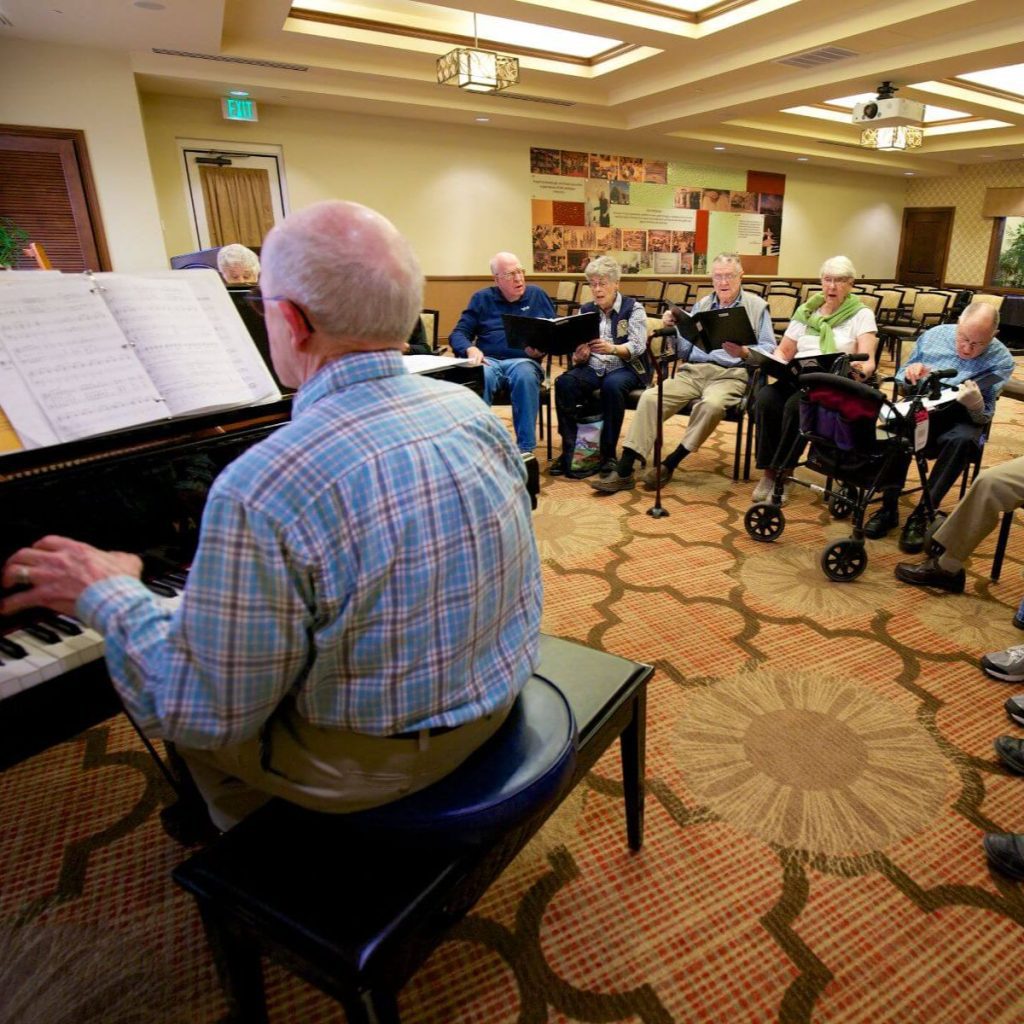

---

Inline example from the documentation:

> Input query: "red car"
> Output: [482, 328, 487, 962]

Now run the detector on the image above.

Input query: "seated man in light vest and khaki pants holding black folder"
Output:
[590, 253, 775, 490]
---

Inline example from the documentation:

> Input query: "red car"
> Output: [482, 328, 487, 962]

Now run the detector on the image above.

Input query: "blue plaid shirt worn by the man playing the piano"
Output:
[78, 352, 542, 749]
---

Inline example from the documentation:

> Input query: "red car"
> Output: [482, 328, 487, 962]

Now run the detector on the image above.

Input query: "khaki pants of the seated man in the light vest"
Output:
[624, 362, 746, 459]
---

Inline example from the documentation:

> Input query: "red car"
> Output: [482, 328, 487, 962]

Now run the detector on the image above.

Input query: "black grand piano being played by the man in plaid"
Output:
[0, 362, 495, 769]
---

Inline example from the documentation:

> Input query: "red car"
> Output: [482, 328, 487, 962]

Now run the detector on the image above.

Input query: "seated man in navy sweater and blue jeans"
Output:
[449, 253, 555, 454]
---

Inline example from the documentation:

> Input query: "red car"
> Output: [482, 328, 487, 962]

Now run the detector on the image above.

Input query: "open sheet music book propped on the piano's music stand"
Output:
[0, 270, 281, 449]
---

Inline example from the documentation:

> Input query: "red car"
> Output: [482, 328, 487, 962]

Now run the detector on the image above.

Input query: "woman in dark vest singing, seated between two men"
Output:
[549, 256, 649, 476]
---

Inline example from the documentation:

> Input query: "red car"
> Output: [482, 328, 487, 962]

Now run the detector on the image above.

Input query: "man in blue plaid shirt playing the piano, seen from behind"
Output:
[0, 202, 542, 828]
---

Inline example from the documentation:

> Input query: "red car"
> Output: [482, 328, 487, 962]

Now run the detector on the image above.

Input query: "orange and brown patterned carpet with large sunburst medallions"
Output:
[0, 356, 1024, 1024]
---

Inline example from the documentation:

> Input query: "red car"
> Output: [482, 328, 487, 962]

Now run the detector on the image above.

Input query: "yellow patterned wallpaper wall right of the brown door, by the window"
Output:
[906, 160, 1024, 285]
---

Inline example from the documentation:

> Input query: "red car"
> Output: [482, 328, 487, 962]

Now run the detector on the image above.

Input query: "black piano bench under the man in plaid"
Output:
[173, 636, 653, 1024]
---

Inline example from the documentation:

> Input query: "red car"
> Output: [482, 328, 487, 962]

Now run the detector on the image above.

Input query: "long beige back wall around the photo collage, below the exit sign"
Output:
[141, 94, 906, 278]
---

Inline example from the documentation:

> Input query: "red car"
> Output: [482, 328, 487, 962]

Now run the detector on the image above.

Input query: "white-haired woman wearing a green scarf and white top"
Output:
[754, 256, 879, 502]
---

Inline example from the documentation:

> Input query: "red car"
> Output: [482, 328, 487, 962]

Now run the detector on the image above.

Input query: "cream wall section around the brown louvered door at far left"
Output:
[0, 40, 167, 271]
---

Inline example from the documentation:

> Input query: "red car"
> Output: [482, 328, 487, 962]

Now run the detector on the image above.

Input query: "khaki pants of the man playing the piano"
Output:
[177, 701, 508, 830]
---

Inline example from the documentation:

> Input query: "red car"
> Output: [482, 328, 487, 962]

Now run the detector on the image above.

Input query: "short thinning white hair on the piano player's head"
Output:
[263, 200, 423, 343]
